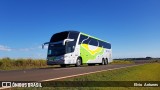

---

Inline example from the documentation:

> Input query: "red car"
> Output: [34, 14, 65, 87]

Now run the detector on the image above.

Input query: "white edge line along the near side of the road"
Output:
[41, 64, 143, 82]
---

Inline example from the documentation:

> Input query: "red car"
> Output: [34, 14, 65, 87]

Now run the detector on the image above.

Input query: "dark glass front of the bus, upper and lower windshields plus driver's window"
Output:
[48, 32, 79, 57]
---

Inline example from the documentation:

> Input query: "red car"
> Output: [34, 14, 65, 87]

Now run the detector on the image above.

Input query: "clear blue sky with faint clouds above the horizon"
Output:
[0, 0, 160, 58]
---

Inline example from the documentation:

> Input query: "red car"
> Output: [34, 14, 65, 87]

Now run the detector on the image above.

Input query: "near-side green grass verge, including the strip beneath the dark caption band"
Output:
[13, 63, 160, 90]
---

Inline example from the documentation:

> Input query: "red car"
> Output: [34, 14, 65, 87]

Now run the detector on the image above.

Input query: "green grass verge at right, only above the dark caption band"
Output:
[64, 63, 160, 81]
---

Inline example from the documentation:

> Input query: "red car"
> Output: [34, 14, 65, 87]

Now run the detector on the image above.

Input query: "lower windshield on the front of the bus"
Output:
[48, 44, 66, 57]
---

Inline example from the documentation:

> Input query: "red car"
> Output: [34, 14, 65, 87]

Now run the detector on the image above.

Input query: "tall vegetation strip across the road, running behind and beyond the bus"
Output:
[0, 57, 160, 70]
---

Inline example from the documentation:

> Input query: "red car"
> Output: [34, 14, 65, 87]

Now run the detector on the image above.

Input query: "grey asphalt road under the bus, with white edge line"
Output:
[0, 63, 143, 81]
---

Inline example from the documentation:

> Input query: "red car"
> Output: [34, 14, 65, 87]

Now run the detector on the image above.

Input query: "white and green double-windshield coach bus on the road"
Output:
[42, 31, 112, 67]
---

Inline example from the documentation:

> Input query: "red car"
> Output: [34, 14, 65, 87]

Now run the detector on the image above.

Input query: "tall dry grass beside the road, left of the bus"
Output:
[0, 58, 47, 70]
